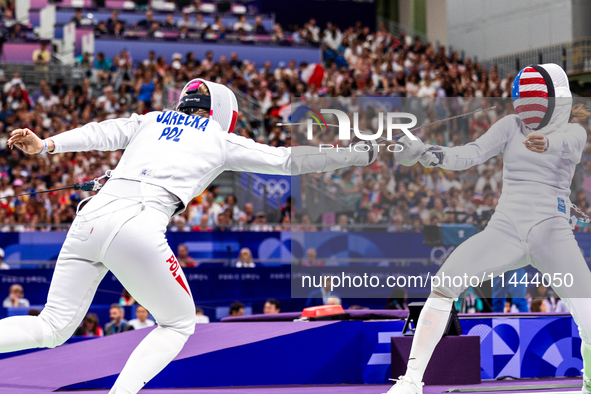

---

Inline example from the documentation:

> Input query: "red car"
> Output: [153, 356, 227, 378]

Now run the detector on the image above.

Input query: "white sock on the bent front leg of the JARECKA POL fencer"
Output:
[109, 327, 189, 394]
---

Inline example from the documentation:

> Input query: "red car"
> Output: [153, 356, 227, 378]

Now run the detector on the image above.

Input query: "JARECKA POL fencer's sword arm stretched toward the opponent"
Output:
[224, 134, 377, 175]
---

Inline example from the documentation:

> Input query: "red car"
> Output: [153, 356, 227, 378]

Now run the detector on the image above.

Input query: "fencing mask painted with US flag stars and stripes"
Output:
[511, 63, 572, 135]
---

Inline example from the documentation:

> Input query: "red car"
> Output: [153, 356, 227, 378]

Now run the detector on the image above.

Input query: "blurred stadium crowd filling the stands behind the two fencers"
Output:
[0, 10, 591, 231]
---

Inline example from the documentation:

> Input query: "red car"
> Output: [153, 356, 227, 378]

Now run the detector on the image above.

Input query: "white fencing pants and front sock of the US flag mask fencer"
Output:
[407, 212, 591, 382]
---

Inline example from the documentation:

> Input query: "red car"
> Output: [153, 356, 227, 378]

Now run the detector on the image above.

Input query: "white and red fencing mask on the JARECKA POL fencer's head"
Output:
[177, 78, 238, 133]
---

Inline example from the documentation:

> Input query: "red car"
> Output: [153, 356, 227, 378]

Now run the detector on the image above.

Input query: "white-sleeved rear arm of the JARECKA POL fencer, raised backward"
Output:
[51, 114, 142, 153]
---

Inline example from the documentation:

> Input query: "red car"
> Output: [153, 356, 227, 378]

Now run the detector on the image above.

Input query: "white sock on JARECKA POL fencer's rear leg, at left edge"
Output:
[0, 316, 51, 353]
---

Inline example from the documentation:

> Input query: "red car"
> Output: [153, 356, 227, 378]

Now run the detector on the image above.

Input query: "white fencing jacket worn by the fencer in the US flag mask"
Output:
[440, 115, 587, 237]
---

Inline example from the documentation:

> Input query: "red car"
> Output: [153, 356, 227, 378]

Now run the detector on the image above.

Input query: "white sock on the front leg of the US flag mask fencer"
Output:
[406, 295, 453, 384]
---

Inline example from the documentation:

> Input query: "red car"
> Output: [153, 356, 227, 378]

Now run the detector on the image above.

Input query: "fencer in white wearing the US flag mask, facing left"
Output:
[388, 64, 591, 394]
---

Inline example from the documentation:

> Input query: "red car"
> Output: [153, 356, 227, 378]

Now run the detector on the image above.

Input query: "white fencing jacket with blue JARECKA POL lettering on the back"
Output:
[50, 111, 369, 211]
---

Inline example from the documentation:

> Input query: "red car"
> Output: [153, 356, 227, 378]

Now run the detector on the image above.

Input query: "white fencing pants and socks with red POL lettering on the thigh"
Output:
[0, 181, 195, 394]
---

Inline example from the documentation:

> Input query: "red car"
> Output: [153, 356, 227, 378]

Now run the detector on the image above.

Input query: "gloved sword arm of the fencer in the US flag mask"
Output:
[421, 116, 519, 170]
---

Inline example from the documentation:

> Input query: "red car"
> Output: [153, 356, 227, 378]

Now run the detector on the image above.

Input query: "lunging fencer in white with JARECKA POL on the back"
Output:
[0, 79, 377, 394]
